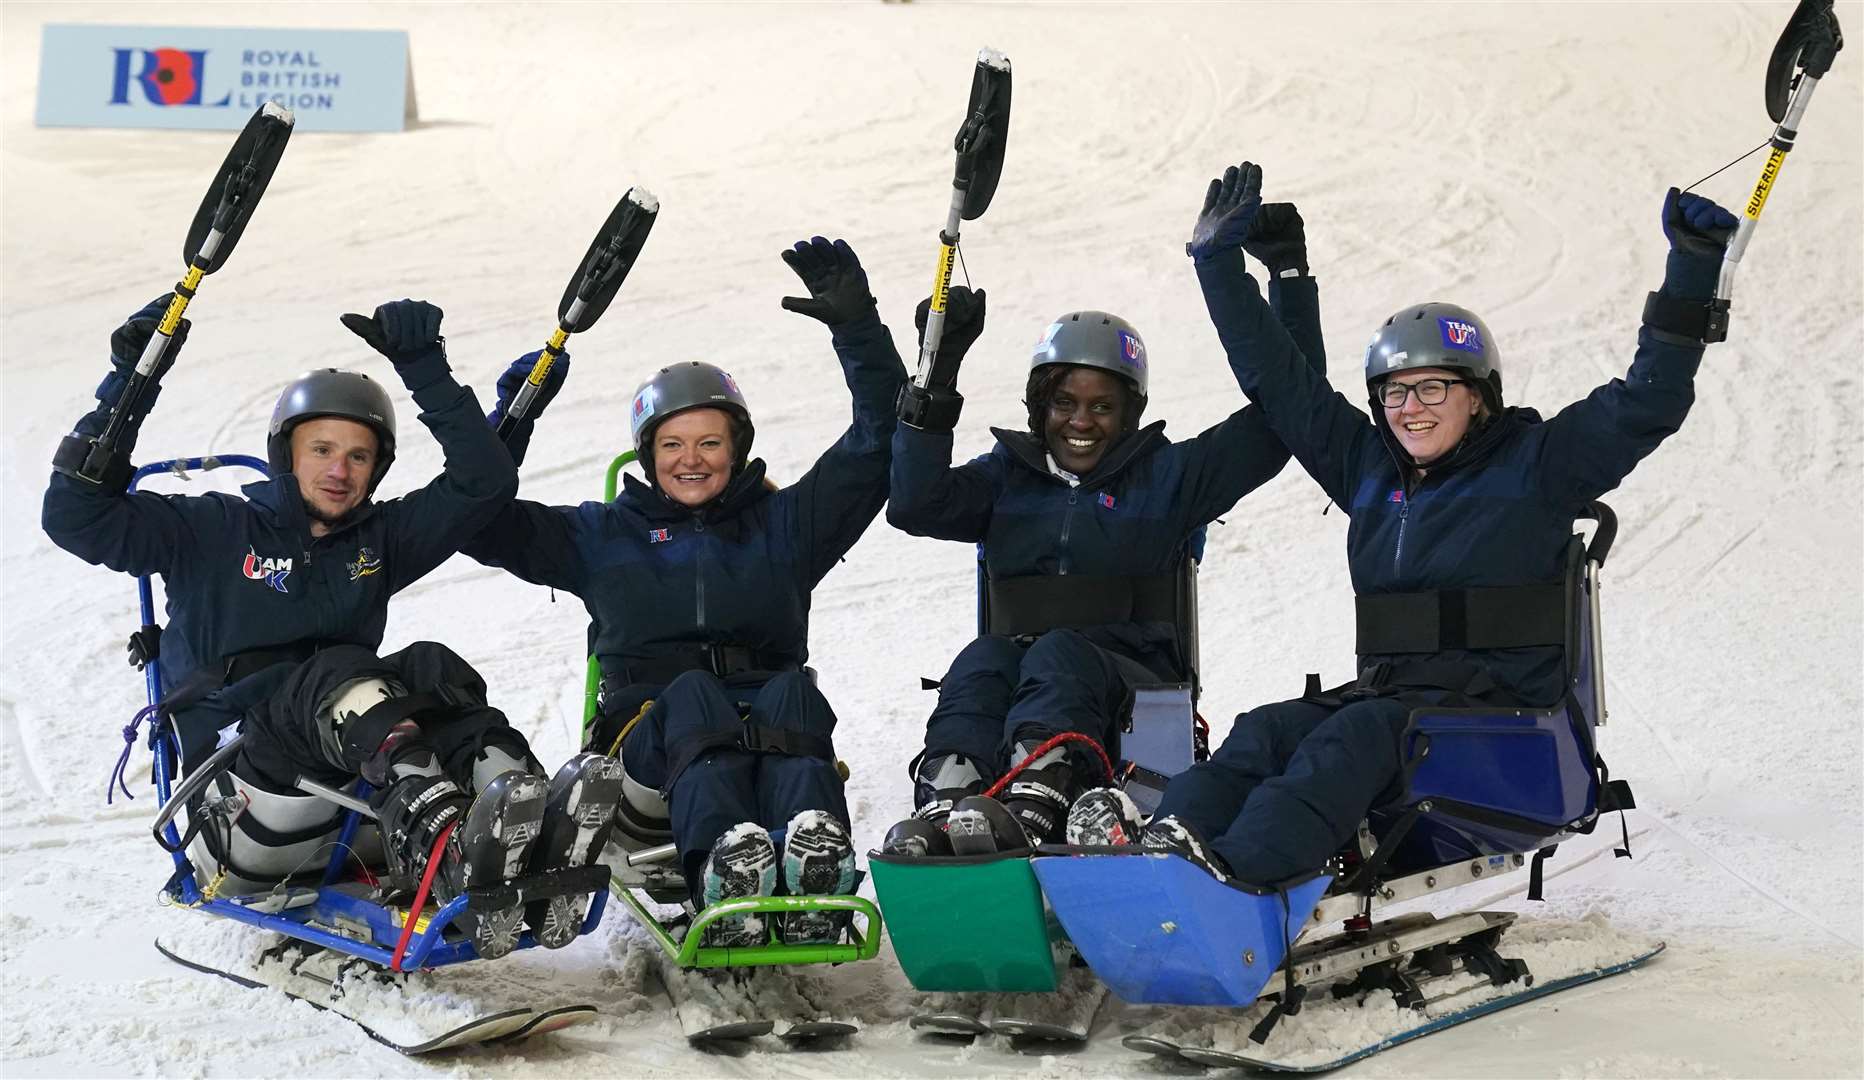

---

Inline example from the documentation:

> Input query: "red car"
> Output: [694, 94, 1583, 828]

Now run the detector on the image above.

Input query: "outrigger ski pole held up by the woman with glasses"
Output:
[1709, 0, 1845, 333]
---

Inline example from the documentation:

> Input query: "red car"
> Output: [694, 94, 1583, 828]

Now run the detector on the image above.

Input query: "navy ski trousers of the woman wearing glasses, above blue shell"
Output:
[1154, 694, 1446, 884]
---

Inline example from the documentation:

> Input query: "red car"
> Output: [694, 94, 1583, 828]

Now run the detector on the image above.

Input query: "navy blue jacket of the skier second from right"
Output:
[887, 278, 1325, 677]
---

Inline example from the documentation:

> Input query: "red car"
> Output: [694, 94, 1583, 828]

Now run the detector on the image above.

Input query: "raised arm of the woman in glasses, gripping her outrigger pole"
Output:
[1540, 188, 1735, 505]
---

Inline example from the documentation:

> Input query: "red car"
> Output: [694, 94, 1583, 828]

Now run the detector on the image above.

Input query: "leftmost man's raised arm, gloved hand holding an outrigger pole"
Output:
[39, 293, 205, 575]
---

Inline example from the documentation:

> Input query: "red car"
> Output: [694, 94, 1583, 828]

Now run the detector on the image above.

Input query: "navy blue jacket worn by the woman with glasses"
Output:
[1197, 244, 1715, 705]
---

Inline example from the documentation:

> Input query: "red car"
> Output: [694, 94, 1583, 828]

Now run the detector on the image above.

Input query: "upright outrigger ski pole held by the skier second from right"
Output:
[900, 48, 1010, 427]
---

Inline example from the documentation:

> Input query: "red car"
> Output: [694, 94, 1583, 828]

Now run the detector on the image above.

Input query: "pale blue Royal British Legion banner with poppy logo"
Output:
[35, 24, 410, 131]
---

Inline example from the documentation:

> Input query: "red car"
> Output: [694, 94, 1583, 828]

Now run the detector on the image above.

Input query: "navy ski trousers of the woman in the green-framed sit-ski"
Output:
[621, 672, 850, 888]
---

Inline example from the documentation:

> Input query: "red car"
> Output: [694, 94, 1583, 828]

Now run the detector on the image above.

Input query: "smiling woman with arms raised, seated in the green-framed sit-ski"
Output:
[464, 237, 906, 946]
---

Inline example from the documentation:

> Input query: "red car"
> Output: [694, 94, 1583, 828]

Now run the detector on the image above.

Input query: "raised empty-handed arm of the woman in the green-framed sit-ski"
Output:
[777, 237, 906, 584]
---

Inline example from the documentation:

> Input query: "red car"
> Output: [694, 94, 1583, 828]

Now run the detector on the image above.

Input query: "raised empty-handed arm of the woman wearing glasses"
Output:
[1187, 162, 1381, 505]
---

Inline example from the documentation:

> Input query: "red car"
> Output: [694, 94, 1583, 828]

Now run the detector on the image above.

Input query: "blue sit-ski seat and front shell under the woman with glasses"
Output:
[1033, 502, 1633, 1005]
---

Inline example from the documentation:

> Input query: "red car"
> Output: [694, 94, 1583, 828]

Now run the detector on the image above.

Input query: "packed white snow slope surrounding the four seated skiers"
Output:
[0, 2, 1864, 1076]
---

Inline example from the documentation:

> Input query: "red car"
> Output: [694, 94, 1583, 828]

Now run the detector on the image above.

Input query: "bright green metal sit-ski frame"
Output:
[583, 450, 882, 968]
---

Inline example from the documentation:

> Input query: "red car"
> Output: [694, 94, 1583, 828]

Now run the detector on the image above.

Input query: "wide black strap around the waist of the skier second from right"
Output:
[984, 571, 1180, 638]
